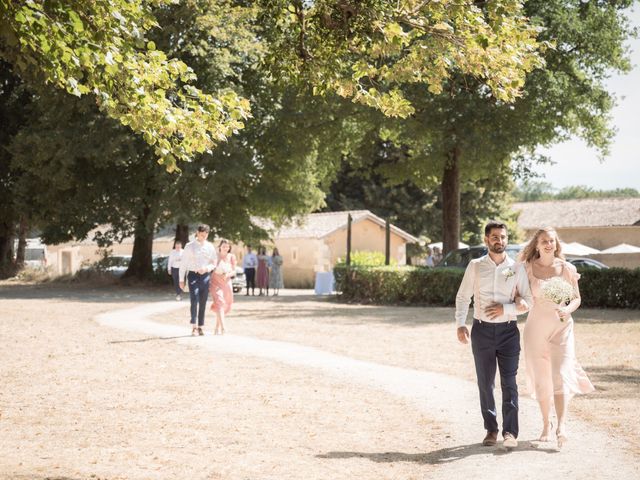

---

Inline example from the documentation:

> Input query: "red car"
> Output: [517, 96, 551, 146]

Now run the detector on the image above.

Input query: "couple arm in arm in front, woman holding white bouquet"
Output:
[455, 222, 594, 448]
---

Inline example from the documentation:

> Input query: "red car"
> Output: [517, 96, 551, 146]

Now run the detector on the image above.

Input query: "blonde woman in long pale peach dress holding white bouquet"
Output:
[521, 227, 594, 448]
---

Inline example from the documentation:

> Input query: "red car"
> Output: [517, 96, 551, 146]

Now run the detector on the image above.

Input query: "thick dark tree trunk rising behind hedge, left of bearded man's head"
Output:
[441, 147, 460, 254]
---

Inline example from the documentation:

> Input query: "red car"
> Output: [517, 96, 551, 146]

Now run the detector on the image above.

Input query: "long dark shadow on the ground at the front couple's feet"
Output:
[316, 441, 558, 465]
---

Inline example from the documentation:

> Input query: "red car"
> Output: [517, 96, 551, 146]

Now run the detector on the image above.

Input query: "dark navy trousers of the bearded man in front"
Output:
[471, 319, 520, 438]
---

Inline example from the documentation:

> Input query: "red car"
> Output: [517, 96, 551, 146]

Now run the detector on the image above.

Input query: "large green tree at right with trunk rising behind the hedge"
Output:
[328, 0, 633, 250]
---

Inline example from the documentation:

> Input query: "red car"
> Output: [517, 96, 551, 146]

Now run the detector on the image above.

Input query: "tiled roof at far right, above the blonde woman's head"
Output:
[512, 198, 640, 230]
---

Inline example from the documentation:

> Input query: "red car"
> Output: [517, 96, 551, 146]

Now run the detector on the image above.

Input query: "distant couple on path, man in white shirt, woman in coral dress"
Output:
[179, 225, 236, 335]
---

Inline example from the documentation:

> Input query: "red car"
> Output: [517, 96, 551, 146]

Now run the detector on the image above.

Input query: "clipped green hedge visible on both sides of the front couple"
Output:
[334, 266, 640, 308]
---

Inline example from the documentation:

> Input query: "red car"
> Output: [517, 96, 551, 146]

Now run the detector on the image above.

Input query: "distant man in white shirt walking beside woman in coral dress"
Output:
[180, 225, 218, 335]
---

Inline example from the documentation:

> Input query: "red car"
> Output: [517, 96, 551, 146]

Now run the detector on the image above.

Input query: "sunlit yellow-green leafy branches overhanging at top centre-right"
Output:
[258, 0, 543, 113]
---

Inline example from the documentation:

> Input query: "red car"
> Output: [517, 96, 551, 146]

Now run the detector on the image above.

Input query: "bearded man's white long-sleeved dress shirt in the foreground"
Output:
[456, 254, 533, 327]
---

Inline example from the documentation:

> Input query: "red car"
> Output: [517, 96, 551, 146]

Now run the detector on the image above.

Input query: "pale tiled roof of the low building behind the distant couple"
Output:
[253, 210, 418, 243]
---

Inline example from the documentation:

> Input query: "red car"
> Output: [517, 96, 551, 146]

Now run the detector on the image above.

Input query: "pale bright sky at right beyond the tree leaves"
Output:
[537, 7, 640, 190]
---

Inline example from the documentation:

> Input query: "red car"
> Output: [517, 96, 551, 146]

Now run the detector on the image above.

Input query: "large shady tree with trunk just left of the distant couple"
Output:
[0, 1, 352, 277]
